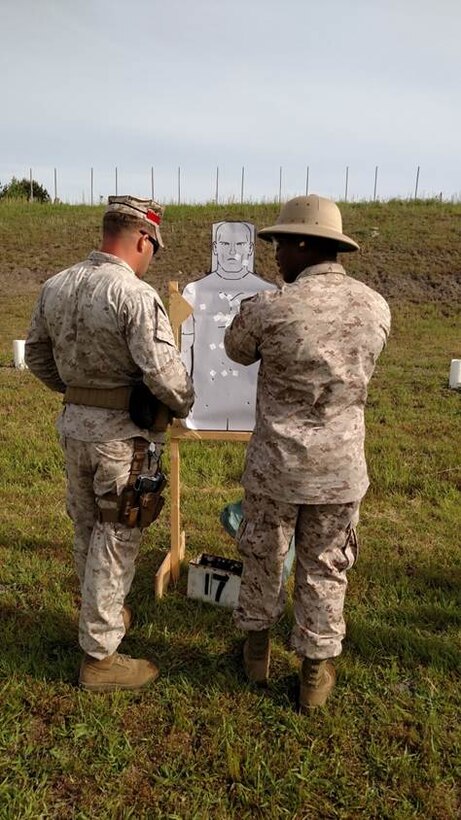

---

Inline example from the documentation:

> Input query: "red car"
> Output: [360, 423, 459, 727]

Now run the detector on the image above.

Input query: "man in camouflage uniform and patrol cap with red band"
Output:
[26, 197, 194, 691]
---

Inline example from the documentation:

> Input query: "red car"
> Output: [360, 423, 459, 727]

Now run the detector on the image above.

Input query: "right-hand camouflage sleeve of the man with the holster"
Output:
[125, 291, 195, 418]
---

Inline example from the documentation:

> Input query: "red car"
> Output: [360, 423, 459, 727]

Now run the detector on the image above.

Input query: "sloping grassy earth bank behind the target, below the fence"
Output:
[0, 201, 461, 306]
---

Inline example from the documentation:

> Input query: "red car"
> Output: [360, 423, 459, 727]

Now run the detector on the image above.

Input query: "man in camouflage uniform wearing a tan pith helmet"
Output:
[225, 195, 390, 706]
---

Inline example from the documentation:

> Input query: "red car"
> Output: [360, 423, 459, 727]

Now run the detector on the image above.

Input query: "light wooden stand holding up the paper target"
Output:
[154, 282, 251, 598]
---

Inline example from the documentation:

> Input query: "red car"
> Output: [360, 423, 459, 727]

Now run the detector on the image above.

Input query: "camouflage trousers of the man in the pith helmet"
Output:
[234, 493, 359, 659]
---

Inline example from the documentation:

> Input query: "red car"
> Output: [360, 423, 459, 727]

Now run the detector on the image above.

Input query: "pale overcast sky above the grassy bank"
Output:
[0, 0, 461, 201]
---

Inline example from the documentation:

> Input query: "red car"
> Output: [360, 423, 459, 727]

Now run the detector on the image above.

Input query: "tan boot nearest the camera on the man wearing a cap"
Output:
[78, 652, 159, 692]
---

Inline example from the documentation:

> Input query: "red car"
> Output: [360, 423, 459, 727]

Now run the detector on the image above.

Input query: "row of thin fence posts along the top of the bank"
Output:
[0, 165, 452, 205]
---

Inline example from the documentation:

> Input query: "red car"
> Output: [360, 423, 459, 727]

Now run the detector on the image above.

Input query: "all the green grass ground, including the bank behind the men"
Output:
[0, 202, 461, 820]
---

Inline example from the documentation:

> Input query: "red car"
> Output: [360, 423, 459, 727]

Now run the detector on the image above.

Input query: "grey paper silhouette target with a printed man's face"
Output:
[181, 222, 275, 431]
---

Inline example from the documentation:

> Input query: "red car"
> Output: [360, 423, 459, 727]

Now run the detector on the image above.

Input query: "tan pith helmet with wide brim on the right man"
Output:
[258, 194, 359, 252]
